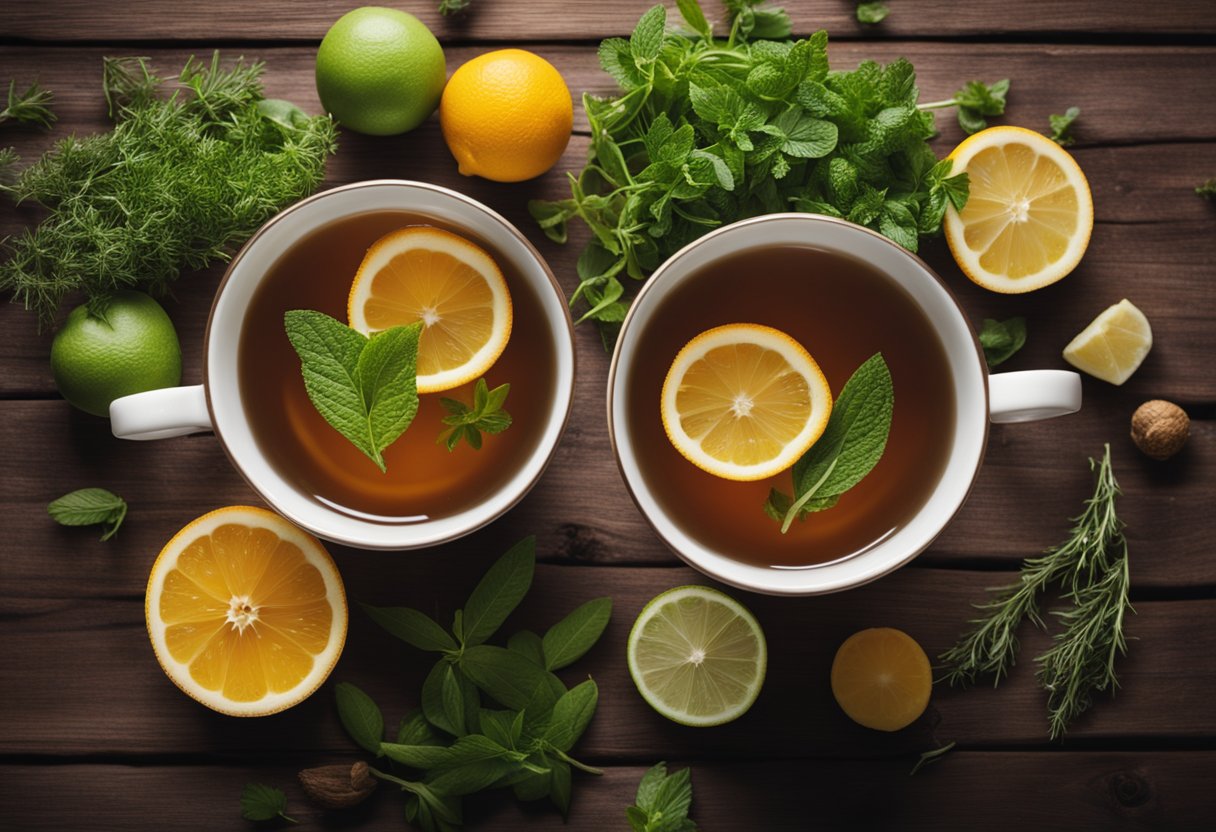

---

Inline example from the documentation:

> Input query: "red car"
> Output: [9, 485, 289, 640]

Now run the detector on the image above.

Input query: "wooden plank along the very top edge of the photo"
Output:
[4, 0, 1216, 41]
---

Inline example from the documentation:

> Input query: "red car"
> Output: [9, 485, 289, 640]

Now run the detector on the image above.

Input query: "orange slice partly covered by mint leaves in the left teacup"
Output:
[347, 225, 512, 393]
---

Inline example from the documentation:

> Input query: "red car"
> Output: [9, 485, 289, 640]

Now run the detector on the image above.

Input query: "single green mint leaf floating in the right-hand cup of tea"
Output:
[765, 353, 895, 534]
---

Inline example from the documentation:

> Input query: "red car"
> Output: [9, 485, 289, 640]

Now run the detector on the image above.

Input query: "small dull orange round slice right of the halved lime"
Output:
[832, 626, 933, 731]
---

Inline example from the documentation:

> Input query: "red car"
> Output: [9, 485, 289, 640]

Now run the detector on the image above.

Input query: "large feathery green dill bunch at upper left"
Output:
[0, 52, 336, 322]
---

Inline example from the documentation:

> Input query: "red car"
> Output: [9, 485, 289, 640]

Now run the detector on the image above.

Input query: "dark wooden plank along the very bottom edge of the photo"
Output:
[0, 752, 1216, 832]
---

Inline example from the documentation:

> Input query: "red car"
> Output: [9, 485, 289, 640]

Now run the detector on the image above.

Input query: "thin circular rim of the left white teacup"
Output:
[202, 179, 578, 551]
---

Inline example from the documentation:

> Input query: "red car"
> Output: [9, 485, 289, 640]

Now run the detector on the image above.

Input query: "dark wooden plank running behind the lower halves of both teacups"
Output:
[0, 401, 1216, 588]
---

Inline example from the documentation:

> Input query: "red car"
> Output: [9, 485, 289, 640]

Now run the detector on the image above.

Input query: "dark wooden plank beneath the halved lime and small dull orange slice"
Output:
[0, 564, 1216, 761]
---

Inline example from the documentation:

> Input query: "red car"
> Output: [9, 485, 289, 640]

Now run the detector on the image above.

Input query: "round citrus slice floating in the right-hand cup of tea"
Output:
[662, 324, 832, 480]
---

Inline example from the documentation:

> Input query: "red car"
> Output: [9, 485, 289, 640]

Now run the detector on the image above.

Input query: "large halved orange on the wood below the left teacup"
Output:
[143, 506, 347, 716]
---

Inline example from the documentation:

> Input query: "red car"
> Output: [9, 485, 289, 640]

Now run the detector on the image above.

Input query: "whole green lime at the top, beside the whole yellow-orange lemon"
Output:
[316, 6, 447, 136]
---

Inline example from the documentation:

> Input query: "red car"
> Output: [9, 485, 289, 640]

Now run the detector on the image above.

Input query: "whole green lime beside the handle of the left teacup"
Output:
[51, 291, 181, 416]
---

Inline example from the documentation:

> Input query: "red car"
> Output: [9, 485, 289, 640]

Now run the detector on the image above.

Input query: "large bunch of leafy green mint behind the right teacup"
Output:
[530, 0, 968, 331]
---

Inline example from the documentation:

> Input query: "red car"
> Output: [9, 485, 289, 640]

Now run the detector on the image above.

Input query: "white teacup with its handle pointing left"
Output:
[109, 180, 574, 549]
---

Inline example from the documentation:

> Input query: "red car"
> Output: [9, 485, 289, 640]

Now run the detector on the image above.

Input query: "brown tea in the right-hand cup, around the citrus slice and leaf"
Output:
[626, 246, 955, 568]
